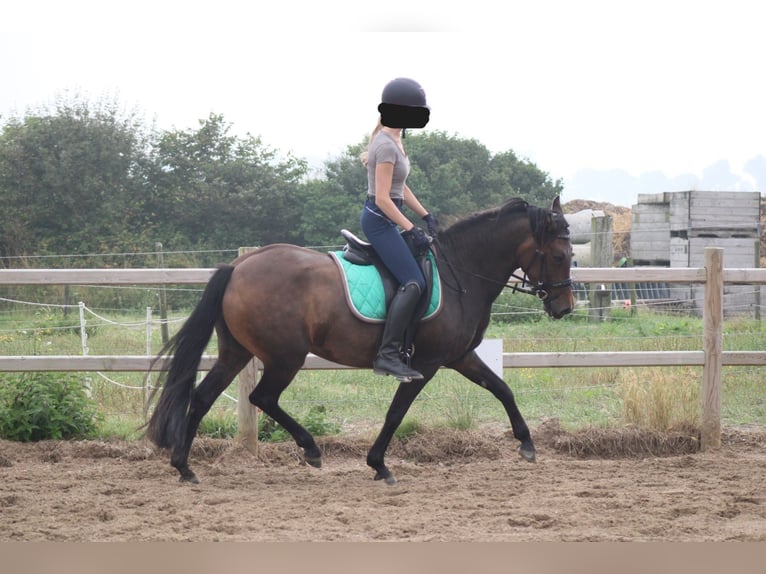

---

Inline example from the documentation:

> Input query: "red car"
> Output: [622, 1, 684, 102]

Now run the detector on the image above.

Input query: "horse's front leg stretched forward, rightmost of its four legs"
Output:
[447, 351, 536, 462]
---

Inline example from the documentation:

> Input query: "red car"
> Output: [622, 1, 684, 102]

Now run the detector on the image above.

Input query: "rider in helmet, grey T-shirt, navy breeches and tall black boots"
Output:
[360, 78, 437, 382]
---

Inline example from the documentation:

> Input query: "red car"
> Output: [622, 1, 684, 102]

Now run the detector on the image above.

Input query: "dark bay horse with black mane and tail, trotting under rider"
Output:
[146, 197, 574, 484]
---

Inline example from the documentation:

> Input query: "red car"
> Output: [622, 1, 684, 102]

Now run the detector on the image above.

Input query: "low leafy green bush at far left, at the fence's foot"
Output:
[0, 373, 99, 442]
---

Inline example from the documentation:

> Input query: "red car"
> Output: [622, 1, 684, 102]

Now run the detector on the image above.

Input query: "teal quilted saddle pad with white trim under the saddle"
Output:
[330, 251, 442, 323]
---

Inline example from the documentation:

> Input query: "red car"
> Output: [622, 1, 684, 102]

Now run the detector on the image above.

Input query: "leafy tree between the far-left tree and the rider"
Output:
[150, 114, 307, 253]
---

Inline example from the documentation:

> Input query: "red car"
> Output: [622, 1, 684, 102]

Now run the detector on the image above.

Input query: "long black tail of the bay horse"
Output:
[146, 265, 234, 448]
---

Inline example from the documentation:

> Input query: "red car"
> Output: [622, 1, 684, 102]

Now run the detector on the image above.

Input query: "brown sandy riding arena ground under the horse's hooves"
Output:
[0, 429, 766, 542]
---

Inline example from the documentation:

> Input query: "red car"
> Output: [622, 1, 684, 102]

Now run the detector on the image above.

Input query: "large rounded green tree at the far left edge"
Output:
[0, 98, 151, 266]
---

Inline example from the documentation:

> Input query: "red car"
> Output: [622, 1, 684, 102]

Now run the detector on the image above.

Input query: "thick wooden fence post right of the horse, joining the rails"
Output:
[700, 247, 723, 450]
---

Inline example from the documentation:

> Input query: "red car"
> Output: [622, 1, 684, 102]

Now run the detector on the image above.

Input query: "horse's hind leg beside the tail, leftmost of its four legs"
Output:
[170, 357, 250, 484]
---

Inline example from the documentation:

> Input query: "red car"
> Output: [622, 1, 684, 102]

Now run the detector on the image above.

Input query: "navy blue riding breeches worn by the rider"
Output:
[359, 198, 426, 293]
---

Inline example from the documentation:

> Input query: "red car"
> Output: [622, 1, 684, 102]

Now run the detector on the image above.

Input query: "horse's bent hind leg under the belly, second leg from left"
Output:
[250, 364, 322, 468]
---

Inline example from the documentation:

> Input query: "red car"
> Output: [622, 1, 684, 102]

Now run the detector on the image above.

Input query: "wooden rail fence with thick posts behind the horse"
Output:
[0, 247, 766, 449]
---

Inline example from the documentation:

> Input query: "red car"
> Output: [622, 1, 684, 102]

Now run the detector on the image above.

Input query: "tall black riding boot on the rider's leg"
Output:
[372, 283, 423, 382]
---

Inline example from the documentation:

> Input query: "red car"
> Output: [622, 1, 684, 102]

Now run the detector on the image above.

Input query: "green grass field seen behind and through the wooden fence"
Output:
[0, 308, 766, 440]
